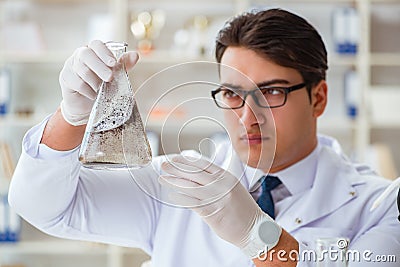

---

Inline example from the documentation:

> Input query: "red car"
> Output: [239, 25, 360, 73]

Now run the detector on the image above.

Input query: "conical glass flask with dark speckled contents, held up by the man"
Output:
[79, 42, 152, 169]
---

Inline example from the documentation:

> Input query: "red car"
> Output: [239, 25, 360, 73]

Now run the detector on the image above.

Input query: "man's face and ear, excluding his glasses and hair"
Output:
[221, 47, 327, 173]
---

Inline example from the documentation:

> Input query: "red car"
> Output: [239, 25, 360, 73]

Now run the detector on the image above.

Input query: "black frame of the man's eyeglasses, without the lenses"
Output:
[211, 83, 307, 109]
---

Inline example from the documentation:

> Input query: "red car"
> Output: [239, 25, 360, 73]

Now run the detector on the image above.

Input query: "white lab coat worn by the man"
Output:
[9, 120, 400, 267]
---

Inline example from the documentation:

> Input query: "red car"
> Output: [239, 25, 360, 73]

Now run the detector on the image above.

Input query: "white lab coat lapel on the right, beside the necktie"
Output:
[279, 148, 358, 232]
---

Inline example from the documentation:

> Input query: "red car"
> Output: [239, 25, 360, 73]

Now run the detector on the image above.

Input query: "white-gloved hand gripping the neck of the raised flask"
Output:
[59, 40, 139, 126]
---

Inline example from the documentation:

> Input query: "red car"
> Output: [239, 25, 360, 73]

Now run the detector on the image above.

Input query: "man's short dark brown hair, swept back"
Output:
[215, 9, 328, 93]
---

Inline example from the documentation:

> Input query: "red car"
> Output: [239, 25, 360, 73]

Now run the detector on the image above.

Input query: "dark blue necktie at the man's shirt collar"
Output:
[257, 175, 282, 219]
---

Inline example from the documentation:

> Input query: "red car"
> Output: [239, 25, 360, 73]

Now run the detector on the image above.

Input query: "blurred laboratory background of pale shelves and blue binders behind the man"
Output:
[0, 0, 400, 267]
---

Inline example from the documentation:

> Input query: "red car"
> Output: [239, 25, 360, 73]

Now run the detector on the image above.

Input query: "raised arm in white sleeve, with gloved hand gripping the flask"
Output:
[9, 41, 159, 247]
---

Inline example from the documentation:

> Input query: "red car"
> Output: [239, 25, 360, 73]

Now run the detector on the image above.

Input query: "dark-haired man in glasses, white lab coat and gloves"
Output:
[9, 9, 400, 267]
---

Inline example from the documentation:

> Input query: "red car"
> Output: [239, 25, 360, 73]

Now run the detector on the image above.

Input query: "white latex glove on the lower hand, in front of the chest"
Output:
[159, 156, 281, 258]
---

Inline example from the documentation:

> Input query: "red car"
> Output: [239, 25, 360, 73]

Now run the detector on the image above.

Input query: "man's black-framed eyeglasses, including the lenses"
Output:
[211, 83, 306, 109]
